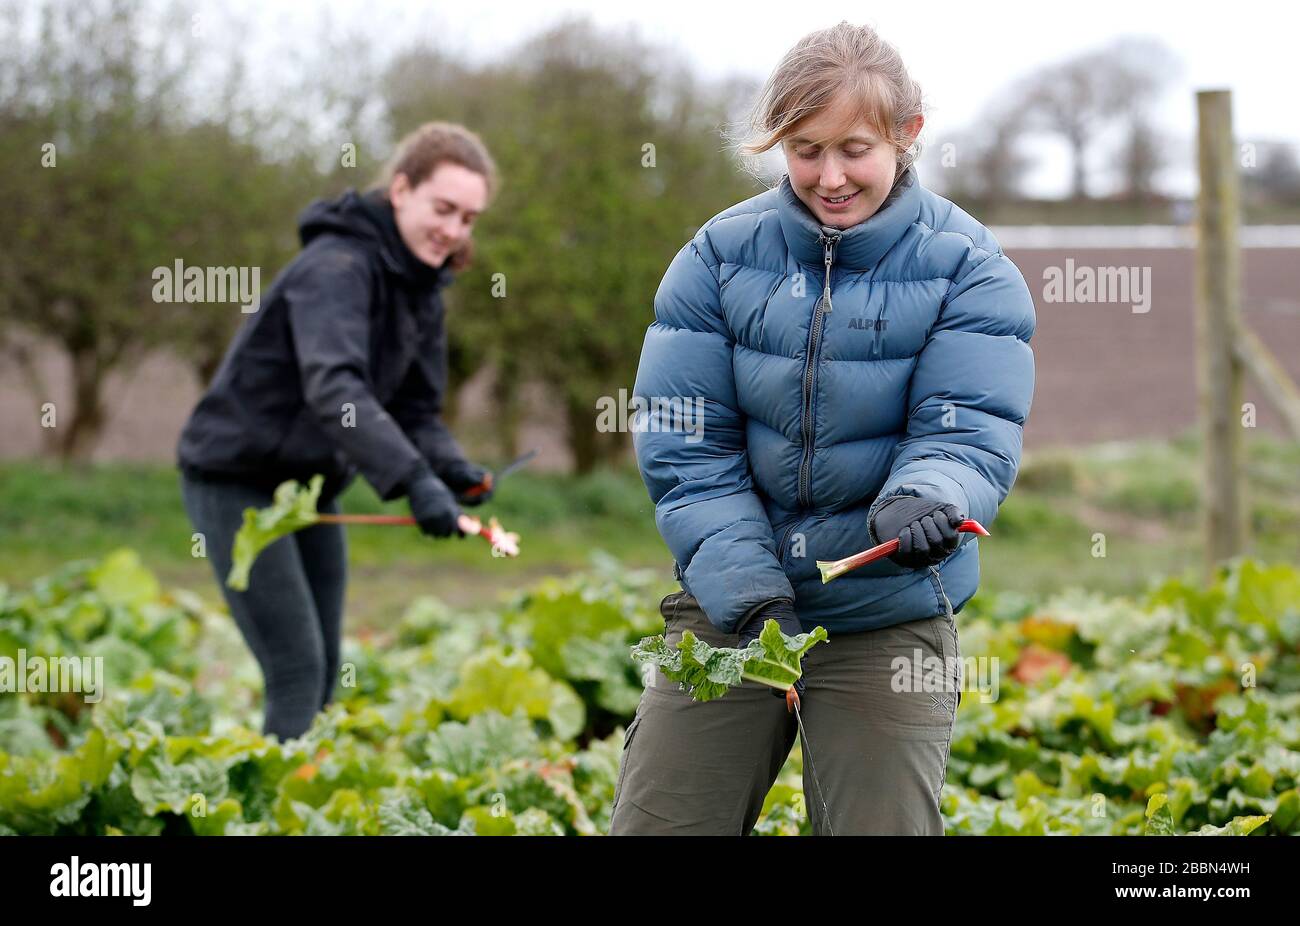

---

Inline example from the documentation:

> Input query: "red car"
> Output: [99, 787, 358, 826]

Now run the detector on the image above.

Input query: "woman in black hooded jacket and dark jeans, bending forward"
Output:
[178, 122, 497, 739]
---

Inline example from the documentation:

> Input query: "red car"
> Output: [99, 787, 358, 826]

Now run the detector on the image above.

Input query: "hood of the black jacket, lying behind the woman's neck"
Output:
[298, 189, 452, 289]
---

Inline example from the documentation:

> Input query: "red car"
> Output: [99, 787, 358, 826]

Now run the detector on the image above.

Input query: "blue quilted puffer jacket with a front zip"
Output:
[632, 168, 1035, 635]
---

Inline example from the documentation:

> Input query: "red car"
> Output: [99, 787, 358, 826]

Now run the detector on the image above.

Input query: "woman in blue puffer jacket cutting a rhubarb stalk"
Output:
[611, 22, 1035, 835]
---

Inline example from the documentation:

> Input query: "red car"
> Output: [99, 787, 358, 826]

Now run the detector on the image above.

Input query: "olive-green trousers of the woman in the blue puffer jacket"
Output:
[610, 592, 962, 836]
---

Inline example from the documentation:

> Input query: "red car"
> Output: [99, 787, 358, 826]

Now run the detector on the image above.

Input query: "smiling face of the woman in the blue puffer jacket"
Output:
[781, 94, 924, 229]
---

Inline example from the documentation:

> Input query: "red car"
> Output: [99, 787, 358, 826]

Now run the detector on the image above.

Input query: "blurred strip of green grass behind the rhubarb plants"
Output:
[0, 434, 1300, 626]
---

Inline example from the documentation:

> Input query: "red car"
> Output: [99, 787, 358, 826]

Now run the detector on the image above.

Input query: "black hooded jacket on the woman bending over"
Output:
[177, 190, 465, 499]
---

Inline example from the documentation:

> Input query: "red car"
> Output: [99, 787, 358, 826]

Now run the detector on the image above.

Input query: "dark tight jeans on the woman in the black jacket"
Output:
[181, 475, 347, 740]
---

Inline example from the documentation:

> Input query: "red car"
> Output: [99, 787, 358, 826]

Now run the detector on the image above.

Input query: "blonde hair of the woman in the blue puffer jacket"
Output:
[738, 21, 924, 177]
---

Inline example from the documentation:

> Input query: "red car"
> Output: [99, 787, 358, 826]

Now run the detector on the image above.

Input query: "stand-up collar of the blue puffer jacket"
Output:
[777, 166, 920, 271]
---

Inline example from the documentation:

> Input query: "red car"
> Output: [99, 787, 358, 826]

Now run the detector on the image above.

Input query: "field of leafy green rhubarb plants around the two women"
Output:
[0, 550, 1300, 835]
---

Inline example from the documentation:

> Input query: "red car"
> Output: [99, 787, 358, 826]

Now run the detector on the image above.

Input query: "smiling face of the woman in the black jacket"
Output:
[389, 161, 488, 267]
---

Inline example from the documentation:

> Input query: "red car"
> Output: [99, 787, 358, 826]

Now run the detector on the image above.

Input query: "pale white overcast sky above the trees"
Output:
[208, 0, 1300, 195]
